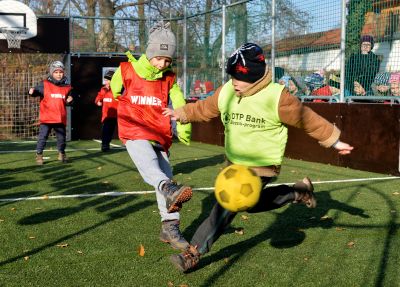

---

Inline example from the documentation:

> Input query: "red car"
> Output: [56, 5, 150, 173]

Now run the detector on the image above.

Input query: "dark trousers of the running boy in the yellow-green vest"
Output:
[190, 177, 295, 254]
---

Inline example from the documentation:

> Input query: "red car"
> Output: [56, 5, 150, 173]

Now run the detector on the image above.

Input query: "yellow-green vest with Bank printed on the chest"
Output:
[218, 81, 287, 166]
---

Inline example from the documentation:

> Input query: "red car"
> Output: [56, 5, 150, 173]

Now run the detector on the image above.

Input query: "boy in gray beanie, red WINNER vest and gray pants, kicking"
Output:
[111, 23, 192, 250]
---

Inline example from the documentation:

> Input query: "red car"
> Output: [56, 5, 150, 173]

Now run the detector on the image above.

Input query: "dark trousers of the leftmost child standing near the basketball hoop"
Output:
[36, 124, 66, 154]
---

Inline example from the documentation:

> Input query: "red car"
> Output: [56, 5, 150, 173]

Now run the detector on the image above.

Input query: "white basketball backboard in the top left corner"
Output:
[0, 0, 37, 40]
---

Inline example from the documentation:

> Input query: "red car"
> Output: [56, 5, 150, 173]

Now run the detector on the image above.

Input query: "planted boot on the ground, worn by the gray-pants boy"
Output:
[160, 220, 189, 250]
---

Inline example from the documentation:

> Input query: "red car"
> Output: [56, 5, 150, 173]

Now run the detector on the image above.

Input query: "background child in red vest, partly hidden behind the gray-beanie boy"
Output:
[94, 70, 118, 152]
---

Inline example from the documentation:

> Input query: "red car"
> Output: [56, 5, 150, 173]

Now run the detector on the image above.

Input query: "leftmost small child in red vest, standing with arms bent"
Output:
[29, 61, 73, 165]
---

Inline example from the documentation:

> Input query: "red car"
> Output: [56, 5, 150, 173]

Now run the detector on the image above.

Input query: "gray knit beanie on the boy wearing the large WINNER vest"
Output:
[146, 22, 176, 60]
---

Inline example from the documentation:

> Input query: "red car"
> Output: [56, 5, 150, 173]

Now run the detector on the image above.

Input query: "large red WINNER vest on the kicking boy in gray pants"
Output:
[118, 62, 175, 151]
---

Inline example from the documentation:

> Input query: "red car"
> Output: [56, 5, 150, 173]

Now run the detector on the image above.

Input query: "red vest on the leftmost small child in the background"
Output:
[39, 80, 71, 125]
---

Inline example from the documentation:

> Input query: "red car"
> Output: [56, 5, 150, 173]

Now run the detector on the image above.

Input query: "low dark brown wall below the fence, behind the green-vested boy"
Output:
[192, 103, 400, 175]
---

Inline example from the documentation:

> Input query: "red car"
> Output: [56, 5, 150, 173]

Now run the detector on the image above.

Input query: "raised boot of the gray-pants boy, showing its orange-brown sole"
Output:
[161, 180, 193, 213]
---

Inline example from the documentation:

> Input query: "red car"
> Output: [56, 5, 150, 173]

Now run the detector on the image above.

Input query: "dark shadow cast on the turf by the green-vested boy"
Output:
[189, 191, 369, 286]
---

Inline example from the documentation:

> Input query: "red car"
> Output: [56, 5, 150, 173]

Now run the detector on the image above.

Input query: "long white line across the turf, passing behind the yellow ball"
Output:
[0, 176, 400, 202]
